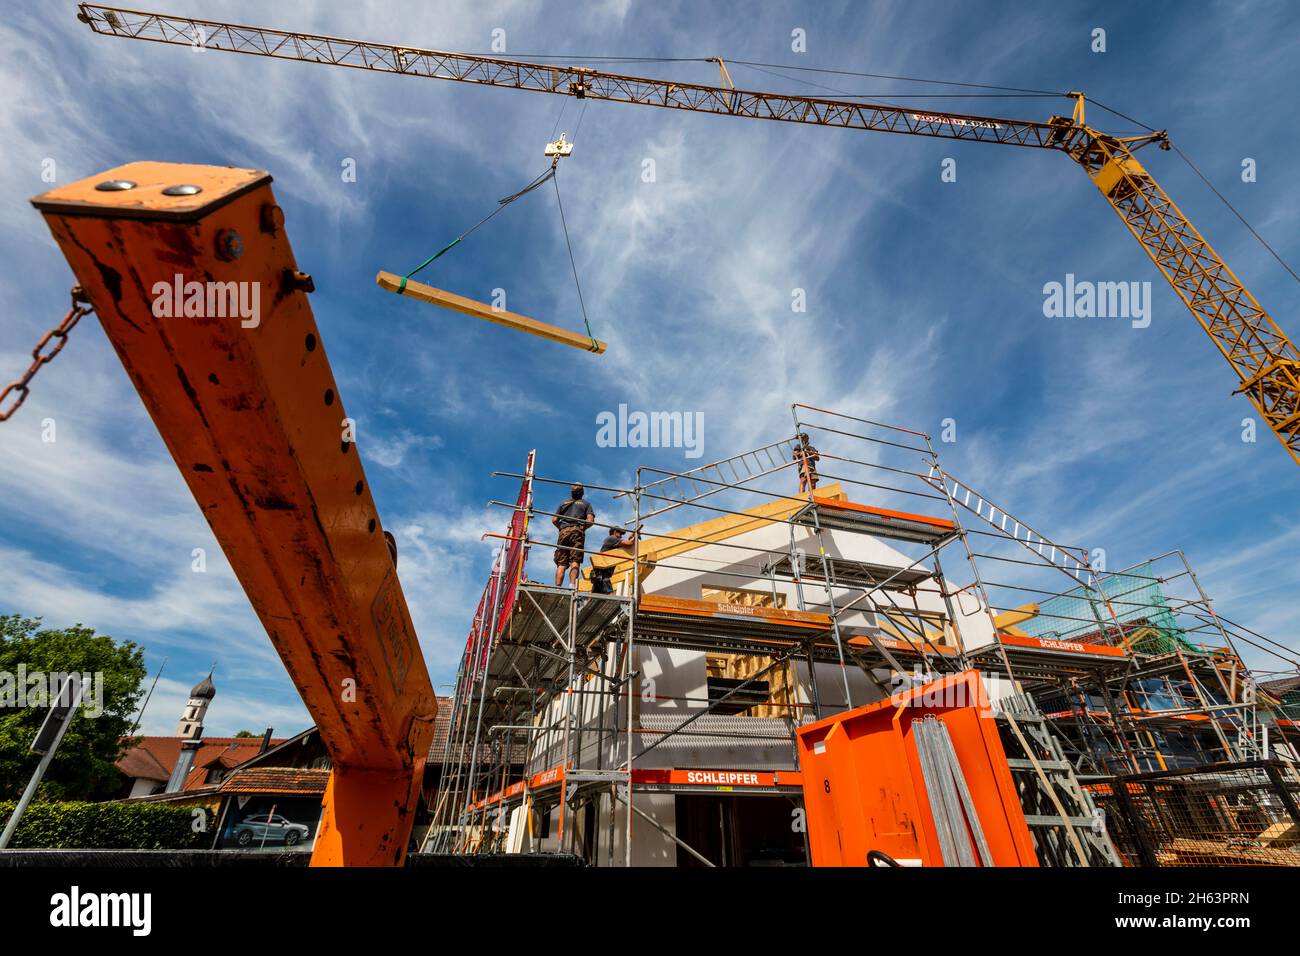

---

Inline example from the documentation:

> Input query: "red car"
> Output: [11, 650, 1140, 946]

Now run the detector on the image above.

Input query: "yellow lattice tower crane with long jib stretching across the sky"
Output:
[77, 3, 1300, 464]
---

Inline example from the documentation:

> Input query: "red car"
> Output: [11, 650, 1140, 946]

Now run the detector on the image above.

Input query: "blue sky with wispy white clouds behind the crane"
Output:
[0, 0, 1300, 734]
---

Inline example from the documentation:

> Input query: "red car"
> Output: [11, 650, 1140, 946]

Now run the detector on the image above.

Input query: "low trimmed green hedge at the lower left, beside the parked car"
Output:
[0, 800, 215, 849]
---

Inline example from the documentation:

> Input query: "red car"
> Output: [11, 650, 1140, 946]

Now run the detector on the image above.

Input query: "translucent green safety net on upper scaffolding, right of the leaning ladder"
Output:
[1017, 563, 1205, 654]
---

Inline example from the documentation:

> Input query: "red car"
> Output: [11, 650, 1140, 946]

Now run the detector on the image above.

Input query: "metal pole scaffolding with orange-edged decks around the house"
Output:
[425, 403, 1289, 865]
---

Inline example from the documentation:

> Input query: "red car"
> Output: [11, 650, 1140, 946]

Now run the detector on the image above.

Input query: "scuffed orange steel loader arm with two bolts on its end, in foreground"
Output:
[33, 163, 437, 865]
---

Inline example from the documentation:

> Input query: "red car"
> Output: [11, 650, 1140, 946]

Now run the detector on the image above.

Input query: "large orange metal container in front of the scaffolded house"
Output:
[798, 670, 1039, 866]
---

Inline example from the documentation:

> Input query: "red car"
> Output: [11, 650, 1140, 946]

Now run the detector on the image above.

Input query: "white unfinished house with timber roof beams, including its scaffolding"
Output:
[426, 405, 1284, 865]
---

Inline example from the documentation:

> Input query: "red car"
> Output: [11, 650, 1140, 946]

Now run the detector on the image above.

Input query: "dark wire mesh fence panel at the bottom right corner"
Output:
[1088, 760, 1300, 866]
